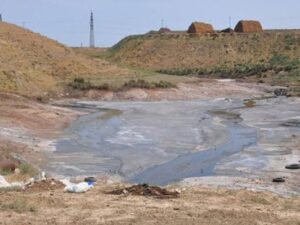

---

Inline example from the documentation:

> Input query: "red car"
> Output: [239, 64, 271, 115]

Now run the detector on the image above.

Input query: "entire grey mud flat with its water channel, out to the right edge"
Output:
[45, 98, 300, 194]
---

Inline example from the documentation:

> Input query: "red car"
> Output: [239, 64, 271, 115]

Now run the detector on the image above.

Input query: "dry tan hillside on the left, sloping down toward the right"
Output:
[0, 22, 128, 96]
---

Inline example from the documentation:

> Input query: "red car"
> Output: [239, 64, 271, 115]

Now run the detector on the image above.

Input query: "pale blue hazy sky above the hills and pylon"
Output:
[0, 0, 300, 46]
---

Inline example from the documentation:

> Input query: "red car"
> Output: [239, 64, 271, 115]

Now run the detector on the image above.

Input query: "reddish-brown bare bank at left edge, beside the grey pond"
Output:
[0, 93, 78, 138]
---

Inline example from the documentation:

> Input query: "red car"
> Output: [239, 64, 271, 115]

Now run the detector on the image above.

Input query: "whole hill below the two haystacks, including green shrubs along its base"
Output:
[89, 30, 300, 93]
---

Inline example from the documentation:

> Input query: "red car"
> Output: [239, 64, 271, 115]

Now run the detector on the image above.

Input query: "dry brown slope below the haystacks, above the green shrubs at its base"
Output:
[105, 30, 300, 70]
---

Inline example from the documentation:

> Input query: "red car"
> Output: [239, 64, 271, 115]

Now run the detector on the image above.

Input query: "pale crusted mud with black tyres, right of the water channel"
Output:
[181, 98, 300, 194]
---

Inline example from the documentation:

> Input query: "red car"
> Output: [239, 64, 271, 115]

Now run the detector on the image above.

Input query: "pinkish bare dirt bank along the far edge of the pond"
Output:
[69, 78, 276, 101]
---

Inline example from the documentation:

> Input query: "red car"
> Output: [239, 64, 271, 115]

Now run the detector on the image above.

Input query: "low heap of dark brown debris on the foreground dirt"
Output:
[108, 184, 179, 198]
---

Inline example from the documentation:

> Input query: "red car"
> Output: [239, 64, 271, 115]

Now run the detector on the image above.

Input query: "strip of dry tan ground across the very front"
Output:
[0, 184, 300, 225]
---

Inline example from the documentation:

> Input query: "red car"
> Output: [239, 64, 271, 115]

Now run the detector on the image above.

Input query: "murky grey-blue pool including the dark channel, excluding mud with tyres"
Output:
[45, 99, 256, 185]
